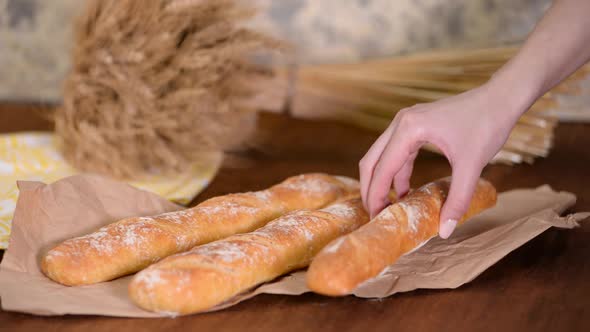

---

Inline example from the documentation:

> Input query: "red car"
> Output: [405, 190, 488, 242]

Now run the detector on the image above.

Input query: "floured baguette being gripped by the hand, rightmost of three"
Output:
[306, 178, 496, 296]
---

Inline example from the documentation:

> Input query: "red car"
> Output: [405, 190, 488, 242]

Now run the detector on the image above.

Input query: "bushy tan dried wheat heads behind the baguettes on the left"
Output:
[53, 0, 280, 178]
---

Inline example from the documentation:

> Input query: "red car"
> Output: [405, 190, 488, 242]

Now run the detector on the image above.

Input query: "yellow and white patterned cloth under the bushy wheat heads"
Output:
[0, 132, 222, 249]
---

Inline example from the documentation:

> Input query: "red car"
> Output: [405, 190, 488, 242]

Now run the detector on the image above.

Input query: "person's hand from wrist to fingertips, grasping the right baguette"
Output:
[359, 83, 528, 238]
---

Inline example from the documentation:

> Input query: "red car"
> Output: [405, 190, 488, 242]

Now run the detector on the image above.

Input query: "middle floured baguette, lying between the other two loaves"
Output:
[129, 198, 369, 314]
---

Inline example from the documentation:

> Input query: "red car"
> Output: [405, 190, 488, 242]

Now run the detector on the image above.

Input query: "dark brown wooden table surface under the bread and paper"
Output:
[0, 105, 590, 332]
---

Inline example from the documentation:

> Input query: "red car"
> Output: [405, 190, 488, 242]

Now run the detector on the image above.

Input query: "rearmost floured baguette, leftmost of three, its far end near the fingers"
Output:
[41, 173, 358, 286]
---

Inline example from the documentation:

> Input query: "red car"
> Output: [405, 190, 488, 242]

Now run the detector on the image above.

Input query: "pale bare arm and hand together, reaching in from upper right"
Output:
[359, 0, 590, 238]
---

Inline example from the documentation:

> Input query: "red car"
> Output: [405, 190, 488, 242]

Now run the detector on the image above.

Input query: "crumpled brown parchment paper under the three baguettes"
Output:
[0, 175, 590, 317]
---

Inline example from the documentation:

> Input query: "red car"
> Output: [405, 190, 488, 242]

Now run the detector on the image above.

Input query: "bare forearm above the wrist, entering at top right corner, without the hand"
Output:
[489, 0, 590, 116]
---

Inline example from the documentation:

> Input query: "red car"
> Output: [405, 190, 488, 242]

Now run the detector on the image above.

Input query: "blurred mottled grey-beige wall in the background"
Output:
[0, 0, 551, 101]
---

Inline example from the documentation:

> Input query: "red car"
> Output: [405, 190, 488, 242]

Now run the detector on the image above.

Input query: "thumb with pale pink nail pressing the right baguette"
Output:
[438, 164, 481, 239]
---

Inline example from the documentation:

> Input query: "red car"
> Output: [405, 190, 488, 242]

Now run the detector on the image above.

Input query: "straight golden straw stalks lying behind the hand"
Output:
[280, 47, 590, 164]
